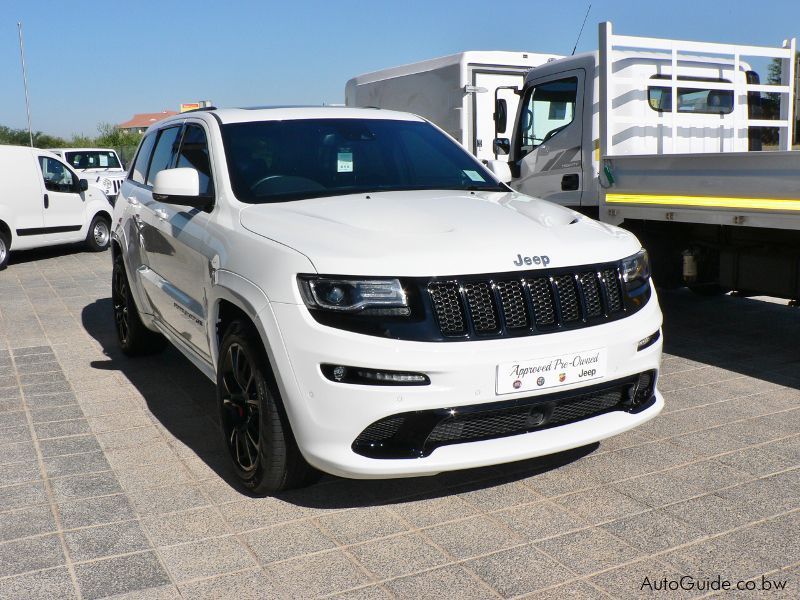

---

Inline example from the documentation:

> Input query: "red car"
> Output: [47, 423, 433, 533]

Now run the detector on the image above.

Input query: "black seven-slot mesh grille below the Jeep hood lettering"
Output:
[427, 264, 625, 338]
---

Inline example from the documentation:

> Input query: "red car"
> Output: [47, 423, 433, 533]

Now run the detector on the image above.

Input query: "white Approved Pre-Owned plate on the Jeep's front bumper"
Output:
[496, 348, 606, 394]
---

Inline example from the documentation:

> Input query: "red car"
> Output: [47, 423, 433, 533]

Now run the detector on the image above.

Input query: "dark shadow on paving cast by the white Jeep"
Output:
[81, 298, 599, 509]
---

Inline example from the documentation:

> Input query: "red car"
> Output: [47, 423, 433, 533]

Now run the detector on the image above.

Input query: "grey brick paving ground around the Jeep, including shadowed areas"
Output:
[0, 248, 800, 599]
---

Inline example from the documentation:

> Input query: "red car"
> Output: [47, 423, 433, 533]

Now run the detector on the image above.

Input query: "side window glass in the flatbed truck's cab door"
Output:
[519, 77, 578, 156]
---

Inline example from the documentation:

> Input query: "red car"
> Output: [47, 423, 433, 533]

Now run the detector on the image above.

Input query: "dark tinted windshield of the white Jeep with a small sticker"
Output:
[222, 119, 506, 203]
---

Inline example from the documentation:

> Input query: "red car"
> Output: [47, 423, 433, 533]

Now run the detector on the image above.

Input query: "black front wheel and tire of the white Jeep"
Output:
[217, 320, 319, 496]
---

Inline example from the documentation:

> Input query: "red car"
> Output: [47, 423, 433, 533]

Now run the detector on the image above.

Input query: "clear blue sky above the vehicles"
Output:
[0, 0, 800, 136]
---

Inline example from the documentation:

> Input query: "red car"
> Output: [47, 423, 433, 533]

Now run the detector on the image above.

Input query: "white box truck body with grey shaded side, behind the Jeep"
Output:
[345, 50, 558, 160]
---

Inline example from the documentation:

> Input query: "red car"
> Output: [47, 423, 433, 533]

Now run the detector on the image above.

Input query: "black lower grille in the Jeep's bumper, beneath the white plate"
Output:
[353, 371, 655, 458]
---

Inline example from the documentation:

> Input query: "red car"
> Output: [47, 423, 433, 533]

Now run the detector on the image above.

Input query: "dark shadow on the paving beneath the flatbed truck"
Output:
[658, 288, 800, 389]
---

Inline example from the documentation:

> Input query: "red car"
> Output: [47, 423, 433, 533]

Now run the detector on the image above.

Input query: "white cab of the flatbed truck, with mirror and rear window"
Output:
[490, 42, 777, 211]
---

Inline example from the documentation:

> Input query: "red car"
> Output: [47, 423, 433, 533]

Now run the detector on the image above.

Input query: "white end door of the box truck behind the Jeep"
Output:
[472, 71, 525, 160]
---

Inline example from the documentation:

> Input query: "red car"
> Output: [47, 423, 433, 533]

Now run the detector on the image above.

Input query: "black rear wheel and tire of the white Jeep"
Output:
[111, 255, 166, 356]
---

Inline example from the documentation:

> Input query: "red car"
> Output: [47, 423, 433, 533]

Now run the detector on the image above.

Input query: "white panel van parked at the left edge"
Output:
[0, 146, 111, 269]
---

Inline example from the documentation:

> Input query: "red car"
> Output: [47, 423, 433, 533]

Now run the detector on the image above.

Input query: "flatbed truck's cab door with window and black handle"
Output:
[511, 69, 589, 206]
